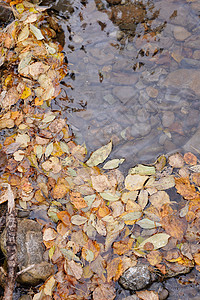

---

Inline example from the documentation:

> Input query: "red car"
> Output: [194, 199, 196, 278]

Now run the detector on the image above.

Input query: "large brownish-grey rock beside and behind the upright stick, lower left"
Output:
[1, 219, 54, 285]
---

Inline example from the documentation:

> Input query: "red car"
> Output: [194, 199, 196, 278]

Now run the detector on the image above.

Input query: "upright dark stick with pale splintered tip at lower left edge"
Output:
[3, 184, 17, 300]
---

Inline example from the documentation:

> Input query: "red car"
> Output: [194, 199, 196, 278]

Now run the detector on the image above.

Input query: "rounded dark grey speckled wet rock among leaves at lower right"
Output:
[119, 264, 156, 291]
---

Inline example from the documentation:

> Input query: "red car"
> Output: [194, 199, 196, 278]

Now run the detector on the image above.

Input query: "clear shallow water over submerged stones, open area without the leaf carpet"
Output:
[45, 0, 200, 170]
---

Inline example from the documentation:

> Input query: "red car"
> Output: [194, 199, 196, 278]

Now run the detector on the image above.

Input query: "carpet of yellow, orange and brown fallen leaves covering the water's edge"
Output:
[0, 1, 200, 300]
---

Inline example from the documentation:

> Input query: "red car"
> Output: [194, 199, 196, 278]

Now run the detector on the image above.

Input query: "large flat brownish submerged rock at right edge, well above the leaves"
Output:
[163, 69, 200, 96]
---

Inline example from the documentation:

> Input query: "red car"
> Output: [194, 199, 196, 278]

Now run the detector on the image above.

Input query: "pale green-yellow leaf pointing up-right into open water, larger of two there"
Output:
[86, 141, 112, 167]
